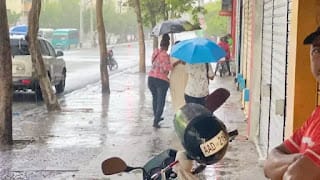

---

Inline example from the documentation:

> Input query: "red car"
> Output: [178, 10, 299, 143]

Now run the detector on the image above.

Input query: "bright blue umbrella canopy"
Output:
[171, 38, 226, 64]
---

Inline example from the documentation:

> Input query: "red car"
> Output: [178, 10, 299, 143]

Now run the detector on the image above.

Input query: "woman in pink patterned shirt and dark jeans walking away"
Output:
[148, 39, 172, 128]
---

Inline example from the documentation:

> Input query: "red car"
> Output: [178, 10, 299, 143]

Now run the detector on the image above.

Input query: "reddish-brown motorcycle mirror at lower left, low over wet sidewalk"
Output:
[101, 157, 128, 175]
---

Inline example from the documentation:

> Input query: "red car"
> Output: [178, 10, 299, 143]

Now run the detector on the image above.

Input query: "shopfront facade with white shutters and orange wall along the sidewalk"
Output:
[232, 0, 320, 159]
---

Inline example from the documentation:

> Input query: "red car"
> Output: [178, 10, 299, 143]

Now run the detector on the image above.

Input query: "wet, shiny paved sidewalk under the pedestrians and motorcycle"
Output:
[0, 68, 265, 180]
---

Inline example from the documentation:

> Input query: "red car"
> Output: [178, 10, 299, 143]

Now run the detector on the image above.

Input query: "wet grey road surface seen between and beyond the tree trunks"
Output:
[13, 41, 152, 114]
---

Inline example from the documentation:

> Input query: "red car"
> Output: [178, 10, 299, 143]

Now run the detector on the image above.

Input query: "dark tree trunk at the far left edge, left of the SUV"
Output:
[0, 1, 13, 144]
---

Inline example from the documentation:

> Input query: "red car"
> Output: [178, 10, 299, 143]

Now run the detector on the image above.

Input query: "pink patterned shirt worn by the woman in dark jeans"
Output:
[148, 49, 172, 81]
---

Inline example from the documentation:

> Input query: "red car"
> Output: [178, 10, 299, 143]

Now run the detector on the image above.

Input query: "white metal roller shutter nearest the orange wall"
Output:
[269, 0, 288, 149]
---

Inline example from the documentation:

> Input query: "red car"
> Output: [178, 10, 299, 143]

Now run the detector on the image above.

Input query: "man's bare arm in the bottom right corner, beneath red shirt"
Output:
[283, 156, 320, 180]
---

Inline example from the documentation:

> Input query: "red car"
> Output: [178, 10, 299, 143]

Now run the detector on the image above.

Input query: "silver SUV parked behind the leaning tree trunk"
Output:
[10, 36, 67, 98]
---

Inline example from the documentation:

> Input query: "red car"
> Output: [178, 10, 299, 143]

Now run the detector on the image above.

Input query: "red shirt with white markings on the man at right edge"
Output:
[284, 107, 320, 167]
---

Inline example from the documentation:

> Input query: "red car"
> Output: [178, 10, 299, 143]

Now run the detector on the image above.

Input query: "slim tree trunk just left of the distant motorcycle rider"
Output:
[96, 0, 110, 94]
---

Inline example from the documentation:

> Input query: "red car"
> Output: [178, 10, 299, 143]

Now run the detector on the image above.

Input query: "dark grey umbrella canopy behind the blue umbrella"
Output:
[151, 19, 201, 36]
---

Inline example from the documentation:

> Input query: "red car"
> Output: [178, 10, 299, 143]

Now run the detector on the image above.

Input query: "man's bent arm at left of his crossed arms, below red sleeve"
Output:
[264, 144, 302, 180]
